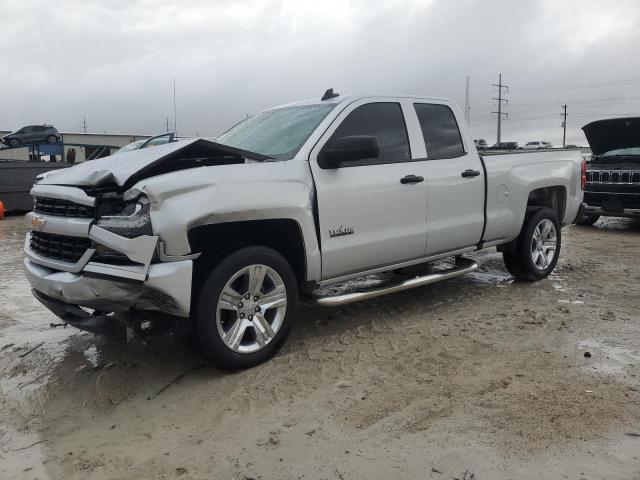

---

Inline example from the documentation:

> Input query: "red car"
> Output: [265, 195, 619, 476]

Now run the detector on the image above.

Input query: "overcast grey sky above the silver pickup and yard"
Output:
[0, 0, 640, 144]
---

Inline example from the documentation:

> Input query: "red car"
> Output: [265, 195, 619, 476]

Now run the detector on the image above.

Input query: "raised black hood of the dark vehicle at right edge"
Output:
[582, 117, 640, 155]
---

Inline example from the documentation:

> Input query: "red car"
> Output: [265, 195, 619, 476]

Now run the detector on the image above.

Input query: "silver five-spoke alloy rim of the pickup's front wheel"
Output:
[216, 264, 287, 353]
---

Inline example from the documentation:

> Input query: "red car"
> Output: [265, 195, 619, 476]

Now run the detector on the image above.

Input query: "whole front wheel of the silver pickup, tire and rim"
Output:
[195, 246, 298, 370]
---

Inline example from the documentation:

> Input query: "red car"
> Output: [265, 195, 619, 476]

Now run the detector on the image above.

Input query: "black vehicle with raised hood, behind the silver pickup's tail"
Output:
[576, 117, 640, 225]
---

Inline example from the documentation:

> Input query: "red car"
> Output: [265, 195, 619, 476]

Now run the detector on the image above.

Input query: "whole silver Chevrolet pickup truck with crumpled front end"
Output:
[24, 90, 585, 369]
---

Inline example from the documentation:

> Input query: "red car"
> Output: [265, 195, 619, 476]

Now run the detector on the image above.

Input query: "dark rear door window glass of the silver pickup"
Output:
[414, 103, 465, 160]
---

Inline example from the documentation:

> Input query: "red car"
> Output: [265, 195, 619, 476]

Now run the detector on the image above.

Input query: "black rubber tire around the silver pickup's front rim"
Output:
[195, 246, 298, 370]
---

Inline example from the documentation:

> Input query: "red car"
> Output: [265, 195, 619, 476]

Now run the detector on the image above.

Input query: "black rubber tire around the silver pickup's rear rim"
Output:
[502, 207, 562, 282]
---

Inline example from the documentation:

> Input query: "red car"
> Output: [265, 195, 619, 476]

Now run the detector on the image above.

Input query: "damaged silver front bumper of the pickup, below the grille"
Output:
[24, 258, 193, 318]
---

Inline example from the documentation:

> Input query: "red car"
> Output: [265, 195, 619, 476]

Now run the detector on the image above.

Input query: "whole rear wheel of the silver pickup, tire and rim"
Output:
[503, 208, 562, 281]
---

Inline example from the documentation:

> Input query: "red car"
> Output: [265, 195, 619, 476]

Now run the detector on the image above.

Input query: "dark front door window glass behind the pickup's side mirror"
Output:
[327, 102, 411, 165]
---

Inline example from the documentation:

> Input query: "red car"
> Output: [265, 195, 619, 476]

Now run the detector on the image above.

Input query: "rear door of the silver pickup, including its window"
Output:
[414, 102, 485, 256]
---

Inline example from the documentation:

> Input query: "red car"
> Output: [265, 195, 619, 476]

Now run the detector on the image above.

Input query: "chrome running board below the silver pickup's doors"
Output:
[304, 257, 478, 307]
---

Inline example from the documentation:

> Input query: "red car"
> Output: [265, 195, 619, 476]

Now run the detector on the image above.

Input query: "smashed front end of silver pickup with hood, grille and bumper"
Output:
[24, 139, 268, 332]
